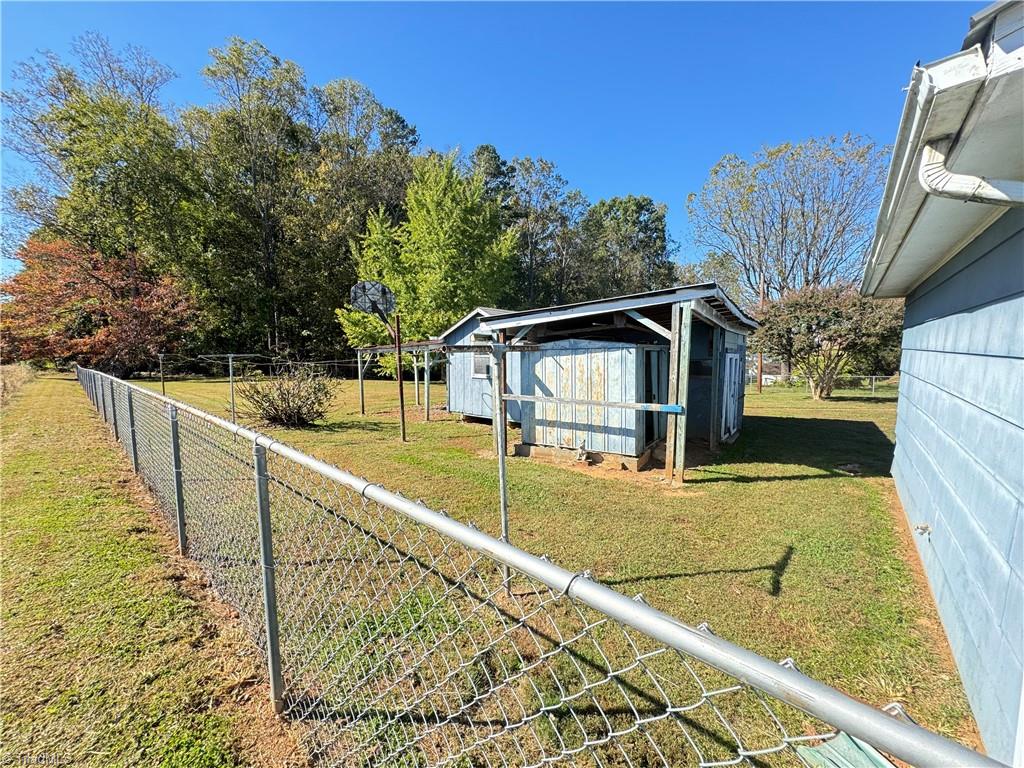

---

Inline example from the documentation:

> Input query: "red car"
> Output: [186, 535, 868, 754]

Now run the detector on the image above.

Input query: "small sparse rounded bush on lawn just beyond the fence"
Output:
[238, 366, 334, 427]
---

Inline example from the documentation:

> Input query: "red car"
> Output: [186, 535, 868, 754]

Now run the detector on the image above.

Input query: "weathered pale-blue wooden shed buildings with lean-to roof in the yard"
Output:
[440, 283, 756, 475]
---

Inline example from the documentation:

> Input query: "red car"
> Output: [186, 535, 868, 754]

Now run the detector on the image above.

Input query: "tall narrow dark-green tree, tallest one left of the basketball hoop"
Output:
[183, 38, 311, 350]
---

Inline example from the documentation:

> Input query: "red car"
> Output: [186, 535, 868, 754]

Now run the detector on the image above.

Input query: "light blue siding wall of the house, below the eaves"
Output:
[893, 209, 1024, 762]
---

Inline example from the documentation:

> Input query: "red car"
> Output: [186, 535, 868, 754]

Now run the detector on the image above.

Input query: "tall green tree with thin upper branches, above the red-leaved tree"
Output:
[3, 35, 197, 333]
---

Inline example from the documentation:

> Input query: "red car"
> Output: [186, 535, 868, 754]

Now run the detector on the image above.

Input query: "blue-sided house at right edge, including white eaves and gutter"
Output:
[861, 2, 1024, 766]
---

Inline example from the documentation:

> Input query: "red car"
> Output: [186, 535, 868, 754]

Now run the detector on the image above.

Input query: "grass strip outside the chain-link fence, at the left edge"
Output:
[0, 378, 302, 768]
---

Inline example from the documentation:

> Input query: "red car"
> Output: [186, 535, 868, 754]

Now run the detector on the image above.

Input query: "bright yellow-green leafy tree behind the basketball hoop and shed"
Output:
[338, 154, 515, 346]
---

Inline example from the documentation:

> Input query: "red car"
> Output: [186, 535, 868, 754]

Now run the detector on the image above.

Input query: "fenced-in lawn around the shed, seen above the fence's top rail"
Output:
[136, 380, 978, 745]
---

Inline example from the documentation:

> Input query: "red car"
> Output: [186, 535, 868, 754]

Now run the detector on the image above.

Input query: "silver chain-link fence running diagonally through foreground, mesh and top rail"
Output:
[78, 369, 998, 768]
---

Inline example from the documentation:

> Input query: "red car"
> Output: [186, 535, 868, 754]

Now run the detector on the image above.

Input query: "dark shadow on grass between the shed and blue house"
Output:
[700, 416, 893, 484]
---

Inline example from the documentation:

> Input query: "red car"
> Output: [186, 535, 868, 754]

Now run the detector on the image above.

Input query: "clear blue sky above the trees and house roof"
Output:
[0, 0, 984, 260]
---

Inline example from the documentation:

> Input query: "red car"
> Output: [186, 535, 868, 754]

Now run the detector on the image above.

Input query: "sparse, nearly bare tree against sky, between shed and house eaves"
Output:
[688, 134, 888, 306]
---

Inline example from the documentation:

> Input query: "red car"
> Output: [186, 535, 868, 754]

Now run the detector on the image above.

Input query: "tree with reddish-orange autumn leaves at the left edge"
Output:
[0, 239, 195, 376]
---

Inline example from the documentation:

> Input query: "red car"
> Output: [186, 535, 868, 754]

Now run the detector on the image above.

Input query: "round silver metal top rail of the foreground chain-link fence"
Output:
[75, 369, 1002, 768]
